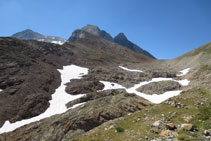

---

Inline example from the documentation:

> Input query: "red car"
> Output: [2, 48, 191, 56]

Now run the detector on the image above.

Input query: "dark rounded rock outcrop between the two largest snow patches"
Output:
[65, 79, 104, 95]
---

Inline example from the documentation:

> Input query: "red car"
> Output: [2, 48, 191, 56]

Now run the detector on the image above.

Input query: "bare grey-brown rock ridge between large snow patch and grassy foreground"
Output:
[0, 90, 151, 141]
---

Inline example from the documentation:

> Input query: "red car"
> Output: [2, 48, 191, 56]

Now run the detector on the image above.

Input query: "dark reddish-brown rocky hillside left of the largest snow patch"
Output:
[0, 38, 72, 127]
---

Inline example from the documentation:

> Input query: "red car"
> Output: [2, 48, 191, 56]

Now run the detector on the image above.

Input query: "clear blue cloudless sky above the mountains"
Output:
[0, 0, 211, 59]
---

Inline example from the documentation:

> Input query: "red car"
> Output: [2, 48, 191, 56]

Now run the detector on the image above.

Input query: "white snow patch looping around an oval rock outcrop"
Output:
[100, 69, 190, 104]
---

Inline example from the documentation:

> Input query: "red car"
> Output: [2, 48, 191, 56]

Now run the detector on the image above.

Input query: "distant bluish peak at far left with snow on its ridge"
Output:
[12, 29, 66, 45]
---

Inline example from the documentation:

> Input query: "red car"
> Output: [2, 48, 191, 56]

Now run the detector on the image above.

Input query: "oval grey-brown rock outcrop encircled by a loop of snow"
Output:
[137, 81, 181, 94]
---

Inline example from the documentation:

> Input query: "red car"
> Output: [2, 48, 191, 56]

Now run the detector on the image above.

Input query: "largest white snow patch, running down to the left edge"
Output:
[0, 65, 88, 134]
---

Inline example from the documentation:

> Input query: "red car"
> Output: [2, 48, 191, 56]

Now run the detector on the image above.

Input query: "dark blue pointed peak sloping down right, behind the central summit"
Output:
[114, 33, 155, 59]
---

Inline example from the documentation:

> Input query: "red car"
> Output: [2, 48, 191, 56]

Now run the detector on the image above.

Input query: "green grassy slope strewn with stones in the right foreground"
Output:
[73, 89, 211, 141]
